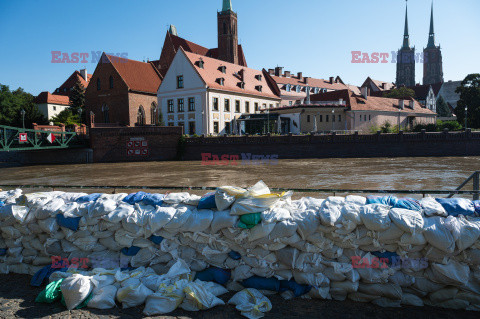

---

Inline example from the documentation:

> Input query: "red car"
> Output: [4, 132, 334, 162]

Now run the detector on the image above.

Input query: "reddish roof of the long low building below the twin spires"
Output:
[310, 90, 436, 115]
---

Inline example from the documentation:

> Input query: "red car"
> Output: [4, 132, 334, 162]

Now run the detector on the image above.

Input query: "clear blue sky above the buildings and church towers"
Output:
[0, 0, 480, 95]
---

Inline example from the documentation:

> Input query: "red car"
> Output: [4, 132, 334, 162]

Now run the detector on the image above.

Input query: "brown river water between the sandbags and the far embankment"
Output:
[0, 157, 480, 197]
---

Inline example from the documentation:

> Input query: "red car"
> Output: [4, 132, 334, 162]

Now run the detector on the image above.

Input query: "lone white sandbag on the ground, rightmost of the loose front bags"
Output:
[228, 288, 272, 319]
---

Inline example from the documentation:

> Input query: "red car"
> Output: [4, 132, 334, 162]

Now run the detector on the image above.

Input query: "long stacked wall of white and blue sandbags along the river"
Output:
[0, 182, 480, 313]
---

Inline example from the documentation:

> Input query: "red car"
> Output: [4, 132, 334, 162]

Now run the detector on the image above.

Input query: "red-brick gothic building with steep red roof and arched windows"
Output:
[85, 53, 162, 126]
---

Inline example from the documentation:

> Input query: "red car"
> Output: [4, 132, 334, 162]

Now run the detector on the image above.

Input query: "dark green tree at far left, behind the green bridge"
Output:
[0, 84, 48, 128]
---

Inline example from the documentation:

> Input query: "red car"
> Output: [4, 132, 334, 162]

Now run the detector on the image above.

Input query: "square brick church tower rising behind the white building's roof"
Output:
[217, 0, 239, 64]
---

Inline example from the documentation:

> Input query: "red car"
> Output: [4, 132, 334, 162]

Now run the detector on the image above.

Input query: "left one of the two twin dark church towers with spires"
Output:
[396, 1, 415, 87]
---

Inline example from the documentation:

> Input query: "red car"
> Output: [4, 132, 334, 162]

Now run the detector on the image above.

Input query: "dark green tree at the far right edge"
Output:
[455, 73, 480, 128]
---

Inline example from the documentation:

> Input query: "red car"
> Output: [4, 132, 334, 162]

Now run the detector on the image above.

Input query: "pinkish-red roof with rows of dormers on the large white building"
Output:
[183, 50, 279, 99]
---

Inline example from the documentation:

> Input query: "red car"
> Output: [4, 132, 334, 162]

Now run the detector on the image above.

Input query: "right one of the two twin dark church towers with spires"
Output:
[423, 2, 443, 84]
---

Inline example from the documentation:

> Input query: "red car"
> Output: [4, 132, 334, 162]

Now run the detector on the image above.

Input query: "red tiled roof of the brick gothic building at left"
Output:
[104, 53, 162, 94]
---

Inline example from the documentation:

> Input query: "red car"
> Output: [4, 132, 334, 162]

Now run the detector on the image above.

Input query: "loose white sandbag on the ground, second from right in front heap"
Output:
[180, 280, 225, 311]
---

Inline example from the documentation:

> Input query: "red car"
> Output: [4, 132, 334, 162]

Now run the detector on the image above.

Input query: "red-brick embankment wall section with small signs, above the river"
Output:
[90, 126, 182, 162]
